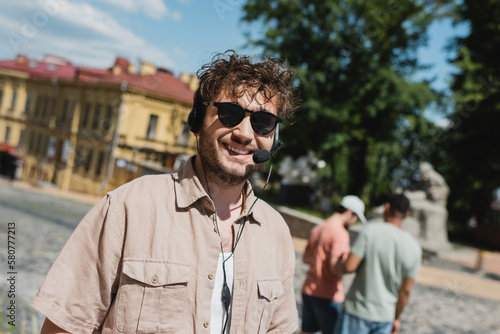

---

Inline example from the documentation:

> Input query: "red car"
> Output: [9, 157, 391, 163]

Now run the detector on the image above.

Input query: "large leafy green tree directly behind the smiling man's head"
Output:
[243, 0, 444, 206]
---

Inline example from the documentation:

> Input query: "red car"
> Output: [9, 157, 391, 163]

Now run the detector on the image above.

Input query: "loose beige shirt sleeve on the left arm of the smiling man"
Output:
[31, 194, 124, 333]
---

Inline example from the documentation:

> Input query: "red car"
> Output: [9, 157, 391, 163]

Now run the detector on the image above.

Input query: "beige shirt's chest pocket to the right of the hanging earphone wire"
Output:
[257, 279, 284, 333]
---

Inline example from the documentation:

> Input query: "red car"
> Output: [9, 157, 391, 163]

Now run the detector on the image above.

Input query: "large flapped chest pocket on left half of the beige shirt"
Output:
[116, 260, 190, 333]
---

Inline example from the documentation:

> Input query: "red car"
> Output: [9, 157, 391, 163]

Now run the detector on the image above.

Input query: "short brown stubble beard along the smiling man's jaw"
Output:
[198, 126, 260, 188]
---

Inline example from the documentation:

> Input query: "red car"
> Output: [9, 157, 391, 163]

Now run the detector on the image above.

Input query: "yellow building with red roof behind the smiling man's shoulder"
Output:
[0, 57, 197, 195]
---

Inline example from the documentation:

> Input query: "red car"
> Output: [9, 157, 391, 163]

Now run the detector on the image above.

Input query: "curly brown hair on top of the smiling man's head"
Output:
[194, 50, 297, 119]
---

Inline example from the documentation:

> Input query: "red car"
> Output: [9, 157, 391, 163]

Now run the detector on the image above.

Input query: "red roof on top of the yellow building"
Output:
[0, 55, 193, 103]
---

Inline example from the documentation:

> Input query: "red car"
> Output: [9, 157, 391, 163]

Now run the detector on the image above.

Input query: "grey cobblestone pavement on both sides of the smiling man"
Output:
[0, 184, 500, 334]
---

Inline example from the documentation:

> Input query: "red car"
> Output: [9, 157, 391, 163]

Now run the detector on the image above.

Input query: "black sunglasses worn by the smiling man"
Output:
[203, 102, 283, 135]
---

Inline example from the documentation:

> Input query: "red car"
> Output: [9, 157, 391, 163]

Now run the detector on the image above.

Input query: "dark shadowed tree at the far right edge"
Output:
[442, 0, 500, 221]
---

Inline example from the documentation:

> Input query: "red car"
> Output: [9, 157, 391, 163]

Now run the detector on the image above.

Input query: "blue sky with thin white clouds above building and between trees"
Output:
[0, 0, 466, 102]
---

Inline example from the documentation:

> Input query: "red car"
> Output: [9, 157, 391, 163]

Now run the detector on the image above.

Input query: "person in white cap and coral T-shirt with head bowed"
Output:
[302, 195, 366, 334]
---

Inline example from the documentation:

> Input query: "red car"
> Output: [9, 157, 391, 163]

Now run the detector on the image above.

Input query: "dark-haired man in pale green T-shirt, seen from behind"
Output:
[336, 194, 422, 334]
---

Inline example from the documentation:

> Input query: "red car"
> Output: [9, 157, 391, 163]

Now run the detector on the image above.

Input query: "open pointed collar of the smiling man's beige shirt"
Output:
[173, 156, 263, 224]
